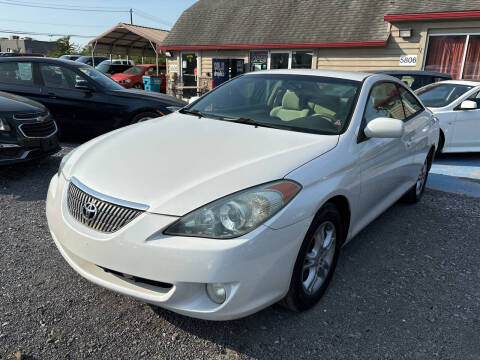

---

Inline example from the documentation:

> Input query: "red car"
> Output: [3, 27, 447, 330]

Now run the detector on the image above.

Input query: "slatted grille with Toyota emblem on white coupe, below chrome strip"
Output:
[67, 183, 143, 233]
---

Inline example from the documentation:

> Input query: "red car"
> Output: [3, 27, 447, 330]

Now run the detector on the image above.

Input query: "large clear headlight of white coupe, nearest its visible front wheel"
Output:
[164, 180, 301, 239]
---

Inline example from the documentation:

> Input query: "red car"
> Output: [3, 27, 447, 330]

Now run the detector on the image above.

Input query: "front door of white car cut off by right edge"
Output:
[450, 91, 480, 151]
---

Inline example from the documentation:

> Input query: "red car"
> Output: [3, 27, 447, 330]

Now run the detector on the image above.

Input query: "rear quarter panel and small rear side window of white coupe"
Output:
[398, 85, 435, 172]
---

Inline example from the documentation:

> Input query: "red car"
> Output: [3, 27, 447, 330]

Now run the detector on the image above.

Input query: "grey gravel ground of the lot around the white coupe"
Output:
[0, 147, 480, 360]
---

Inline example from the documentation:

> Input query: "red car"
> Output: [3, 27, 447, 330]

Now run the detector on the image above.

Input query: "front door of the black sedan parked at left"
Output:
[39, 63, 95, 135]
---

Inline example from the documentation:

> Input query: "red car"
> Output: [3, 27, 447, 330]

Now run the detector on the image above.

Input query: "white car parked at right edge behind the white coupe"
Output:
[416, 80, 480, 153]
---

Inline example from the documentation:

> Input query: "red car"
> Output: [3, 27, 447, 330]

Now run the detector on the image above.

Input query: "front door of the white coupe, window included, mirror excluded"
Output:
[357, 81, 413, 227]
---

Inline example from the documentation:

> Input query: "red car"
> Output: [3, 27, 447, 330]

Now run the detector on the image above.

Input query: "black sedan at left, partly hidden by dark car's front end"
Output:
[0, 58, 185, 137]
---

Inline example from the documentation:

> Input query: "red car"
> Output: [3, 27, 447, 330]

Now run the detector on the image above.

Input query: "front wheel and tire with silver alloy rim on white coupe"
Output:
[280, 203, 344, 311]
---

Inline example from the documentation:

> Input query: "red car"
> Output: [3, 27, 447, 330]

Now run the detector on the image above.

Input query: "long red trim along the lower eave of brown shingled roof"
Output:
[158, 40, 387, 51]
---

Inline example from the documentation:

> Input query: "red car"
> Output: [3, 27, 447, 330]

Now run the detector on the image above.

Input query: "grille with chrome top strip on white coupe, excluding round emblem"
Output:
[67, 178, 148, 233]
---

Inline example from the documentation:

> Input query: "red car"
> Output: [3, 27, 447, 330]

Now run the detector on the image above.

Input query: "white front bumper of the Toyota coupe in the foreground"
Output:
[47, 175, 311, 320]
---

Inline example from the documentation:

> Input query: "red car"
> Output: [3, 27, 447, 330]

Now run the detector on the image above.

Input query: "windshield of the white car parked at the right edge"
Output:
[415, 83, 473, 107]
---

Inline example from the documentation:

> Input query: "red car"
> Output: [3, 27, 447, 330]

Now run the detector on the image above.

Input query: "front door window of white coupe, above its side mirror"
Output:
[364, 82, 405, 125]
